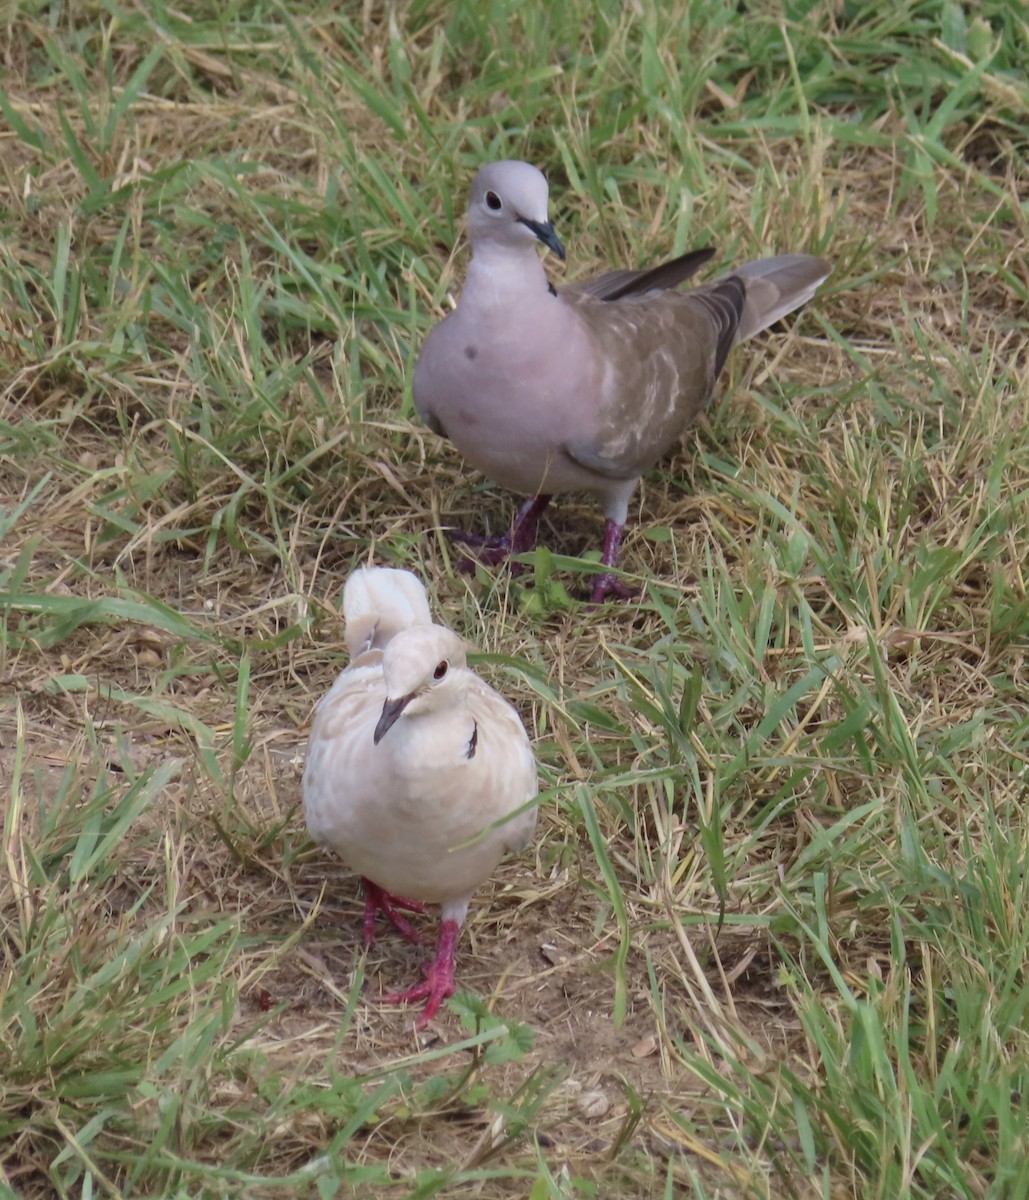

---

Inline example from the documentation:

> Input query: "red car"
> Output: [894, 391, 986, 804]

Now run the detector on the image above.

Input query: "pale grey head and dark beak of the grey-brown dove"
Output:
[468, 160, 565, 262]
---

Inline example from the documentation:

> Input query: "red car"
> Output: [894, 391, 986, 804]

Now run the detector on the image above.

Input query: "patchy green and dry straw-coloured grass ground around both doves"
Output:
[0, 0, 1029, 1200]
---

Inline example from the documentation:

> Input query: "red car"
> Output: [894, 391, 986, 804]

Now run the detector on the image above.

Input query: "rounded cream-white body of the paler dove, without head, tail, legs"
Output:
[305, 648, 536, 907]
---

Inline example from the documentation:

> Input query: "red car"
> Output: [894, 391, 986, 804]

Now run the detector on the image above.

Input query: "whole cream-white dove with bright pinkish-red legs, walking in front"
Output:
[303, 566, 537, 1030]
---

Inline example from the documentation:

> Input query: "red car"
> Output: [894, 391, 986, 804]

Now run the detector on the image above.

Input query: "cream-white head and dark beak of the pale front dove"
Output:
[374, 625, 468, 745]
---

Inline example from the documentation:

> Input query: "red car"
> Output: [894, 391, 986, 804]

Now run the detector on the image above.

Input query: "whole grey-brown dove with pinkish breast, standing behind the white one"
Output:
[411, 161, 831, 604]
